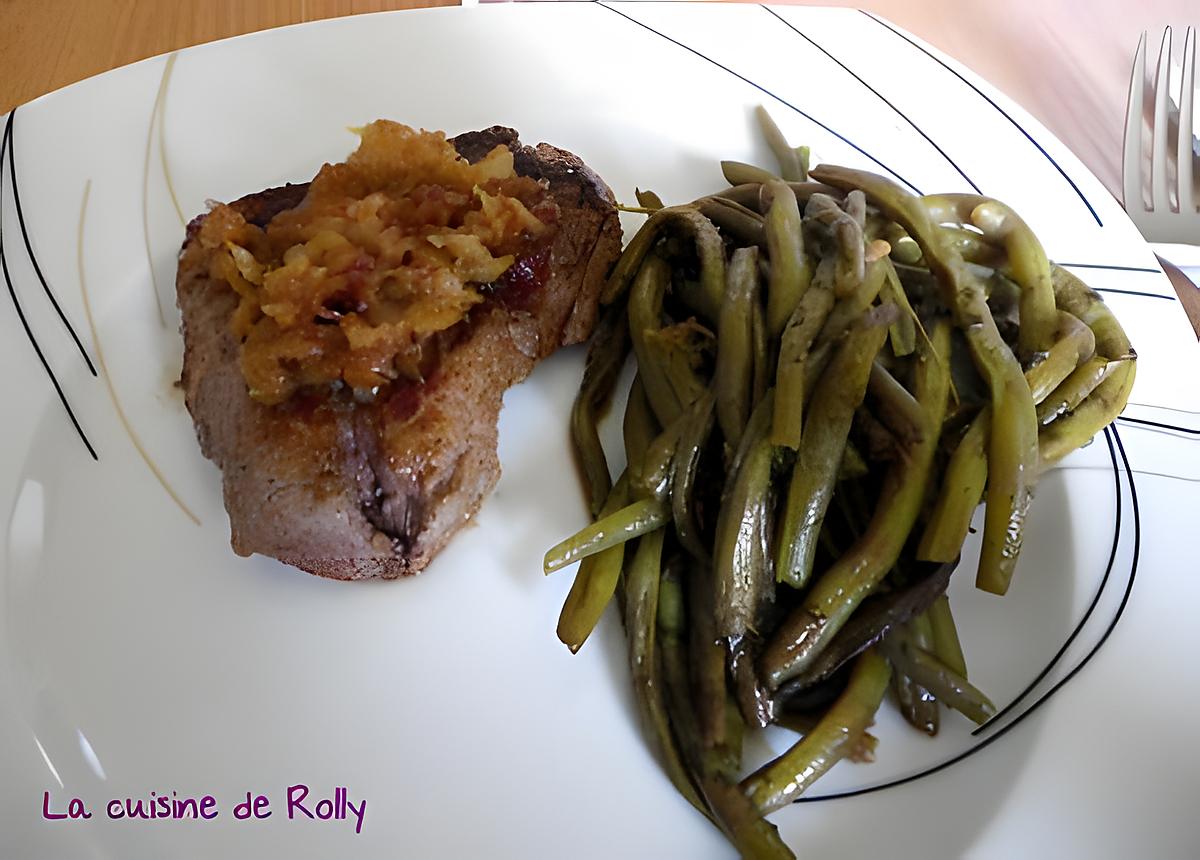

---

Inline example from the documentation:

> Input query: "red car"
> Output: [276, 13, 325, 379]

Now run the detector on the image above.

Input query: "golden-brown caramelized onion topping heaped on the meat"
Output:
[199, 120, 558, 404]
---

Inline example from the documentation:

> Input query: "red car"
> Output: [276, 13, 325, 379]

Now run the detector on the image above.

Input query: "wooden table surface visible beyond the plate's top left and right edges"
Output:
[0, 0, 1200, 336]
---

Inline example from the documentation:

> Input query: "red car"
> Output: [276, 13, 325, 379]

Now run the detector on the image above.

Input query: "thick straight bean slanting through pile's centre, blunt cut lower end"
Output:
[775, 305, 892, 589]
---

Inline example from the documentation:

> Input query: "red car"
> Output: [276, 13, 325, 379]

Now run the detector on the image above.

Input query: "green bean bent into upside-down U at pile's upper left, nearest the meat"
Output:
[600, 206, 725, 320]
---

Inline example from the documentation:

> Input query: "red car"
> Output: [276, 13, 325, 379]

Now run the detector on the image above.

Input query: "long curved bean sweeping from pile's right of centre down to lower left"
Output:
[760, 323, 950, 688]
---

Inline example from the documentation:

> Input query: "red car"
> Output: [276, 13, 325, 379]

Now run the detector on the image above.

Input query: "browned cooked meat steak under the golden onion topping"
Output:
[176, 126, 620, 579]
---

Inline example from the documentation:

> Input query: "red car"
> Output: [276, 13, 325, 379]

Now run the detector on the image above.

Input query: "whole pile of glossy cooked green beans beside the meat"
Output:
[545, 110, 1134, 858]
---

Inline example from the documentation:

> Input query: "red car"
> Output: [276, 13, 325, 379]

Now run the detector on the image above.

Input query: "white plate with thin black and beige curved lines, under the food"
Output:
[0, 4, 1200, 858]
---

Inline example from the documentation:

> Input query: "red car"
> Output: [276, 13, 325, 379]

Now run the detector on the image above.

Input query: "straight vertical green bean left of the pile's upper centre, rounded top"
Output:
[713, 247, 758, 447]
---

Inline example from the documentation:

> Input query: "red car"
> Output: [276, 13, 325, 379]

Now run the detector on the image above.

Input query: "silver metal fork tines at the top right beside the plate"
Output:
[1121, 26, 1200, 245]
